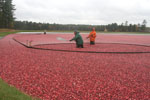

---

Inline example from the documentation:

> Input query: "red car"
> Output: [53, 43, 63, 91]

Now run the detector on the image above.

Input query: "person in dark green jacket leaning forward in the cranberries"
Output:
[69, 31, 83, 48]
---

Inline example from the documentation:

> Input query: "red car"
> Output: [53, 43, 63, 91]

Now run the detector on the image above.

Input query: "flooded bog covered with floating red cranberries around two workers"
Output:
[0, 34, 150, 100]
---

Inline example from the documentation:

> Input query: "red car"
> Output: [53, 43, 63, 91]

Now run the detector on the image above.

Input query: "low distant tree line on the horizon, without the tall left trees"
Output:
[14, 20, 147, 32]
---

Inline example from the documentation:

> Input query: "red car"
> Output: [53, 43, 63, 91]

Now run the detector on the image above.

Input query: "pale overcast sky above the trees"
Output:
[13, 0, 150, 26]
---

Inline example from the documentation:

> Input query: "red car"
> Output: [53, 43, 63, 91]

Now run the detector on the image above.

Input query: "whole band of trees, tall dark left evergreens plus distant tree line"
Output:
[0, 0, 147, 32]
